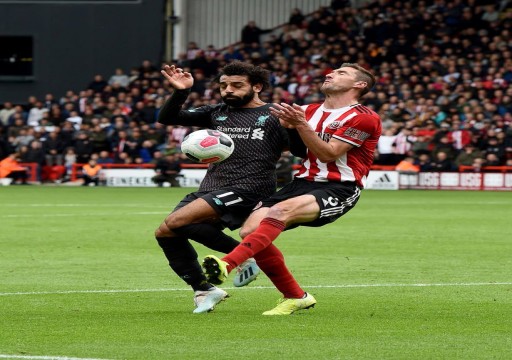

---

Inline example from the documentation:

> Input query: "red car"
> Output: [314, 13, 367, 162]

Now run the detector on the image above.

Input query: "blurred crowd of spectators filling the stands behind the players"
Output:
[0, 0, 512, 181]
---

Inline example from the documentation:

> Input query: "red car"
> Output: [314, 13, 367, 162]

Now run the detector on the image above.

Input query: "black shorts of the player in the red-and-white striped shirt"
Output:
[261, 179, 361, 229]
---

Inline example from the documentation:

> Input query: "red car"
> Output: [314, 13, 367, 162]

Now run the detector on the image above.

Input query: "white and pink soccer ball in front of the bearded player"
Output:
[181, 129, 235, 164]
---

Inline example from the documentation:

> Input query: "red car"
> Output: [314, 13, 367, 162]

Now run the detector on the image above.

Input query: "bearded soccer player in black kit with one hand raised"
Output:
[155, 61, 304, 313]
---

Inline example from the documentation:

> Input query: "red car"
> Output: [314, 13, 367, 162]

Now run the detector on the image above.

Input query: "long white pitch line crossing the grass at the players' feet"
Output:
[0, 282, 512, 296]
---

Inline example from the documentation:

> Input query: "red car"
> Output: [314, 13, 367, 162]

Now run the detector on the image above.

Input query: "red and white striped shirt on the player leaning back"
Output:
[295, 104, 382, 187]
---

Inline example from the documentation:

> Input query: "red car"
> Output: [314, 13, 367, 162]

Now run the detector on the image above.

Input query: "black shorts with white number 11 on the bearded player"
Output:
[174, 188, 261, 230]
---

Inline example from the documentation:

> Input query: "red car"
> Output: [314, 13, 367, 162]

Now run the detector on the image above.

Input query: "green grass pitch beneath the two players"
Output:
[0, 186, 512, 360]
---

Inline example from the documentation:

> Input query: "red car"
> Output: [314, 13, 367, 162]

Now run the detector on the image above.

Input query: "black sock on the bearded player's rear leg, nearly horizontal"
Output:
[173, 224, 239, 254]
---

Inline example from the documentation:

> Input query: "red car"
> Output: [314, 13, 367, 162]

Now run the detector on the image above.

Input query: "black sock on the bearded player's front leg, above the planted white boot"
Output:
[156, 236, 213, 291]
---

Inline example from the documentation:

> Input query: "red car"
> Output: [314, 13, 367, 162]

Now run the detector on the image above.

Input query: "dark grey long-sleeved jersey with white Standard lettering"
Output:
[158, 91, 288, 198]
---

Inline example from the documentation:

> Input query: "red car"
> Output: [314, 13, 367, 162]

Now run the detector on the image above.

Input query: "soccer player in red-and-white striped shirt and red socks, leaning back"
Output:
[203, 63, 381, 315]
